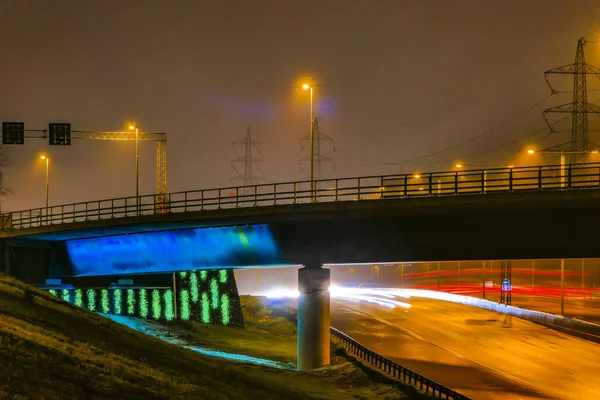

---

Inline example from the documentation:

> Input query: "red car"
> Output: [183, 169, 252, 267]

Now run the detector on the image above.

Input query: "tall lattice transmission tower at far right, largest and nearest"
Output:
[543, 38, 600, 164]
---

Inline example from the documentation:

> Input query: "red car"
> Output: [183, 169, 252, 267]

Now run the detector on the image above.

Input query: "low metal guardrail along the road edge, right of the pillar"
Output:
[329, 327, 470, 400]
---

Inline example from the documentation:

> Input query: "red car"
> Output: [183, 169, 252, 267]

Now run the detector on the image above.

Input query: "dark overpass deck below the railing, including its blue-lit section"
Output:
[2, 190, 600, 282]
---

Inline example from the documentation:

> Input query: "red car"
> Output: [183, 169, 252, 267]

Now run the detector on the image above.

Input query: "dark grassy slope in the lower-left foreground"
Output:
[0, 277, 408, 400]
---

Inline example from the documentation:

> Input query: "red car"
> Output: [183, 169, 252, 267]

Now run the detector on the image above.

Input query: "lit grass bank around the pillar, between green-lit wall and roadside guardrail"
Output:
[164, 296, 427, 400]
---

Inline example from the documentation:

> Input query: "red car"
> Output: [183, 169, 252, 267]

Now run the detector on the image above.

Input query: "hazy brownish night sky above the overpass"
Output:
[0, 0, 600, 210]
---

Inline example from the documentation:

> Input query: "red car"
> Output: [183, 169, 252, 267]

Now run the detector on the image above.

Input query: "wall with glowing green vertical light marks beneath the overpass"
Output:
[48, 269, 244, 327]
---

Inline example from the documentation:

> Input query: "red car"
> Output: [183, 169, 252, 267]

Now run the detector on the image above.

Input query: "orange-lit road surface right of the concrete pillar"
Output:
[331, 298, 600, 400]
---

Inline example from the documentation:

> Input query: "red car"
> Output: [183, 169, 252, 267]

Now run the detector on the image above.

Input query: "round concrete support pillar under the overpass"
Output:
[298, 266, 330, 371]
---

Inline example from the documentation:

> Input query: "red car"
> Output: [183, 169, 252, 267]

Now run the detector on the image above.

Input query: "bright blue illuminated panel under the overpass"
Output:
[66, 225, 283, 276]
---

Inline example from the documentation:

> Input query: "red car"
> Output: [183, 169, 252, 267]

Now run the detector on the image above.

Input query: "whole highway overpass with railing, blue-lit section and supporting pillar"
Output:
[0, 164, 600, 366]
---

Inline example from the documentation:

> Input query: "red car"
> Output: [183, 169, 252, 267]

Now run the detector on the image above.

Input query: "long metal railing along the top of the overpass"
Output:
[0, 163, 600, 230]
